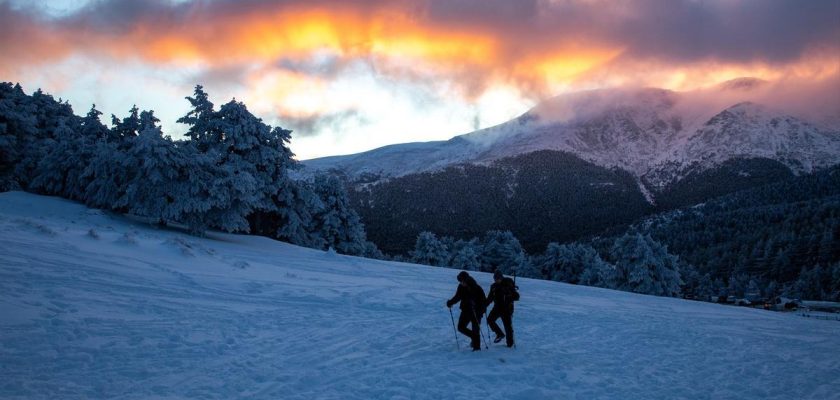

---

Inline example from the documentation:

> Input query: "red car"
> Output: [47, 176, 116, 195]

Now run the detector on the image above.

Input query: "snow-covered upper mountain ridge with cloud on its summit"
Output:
[304, 78, 840, 190]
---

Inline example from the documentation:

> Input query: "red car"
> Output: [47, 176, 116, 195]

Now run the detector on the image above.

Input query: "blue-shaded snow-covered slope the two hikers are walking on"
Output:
[0, 192, 840, 399]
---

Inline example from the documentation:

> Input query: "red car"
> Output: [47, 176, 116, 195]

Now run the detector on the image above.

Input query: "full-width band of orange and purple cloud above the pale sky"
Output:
[0, 0, 840, 103]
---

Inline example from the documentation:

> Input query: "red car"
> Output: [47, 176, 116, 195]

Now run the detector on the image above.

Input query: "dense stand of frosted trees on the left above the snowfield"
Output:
[0, 83, 382, 257]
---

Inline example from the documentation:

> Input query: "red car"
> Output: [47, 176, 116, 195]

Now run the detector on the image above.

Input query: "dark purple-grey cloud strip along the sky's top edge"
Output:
[16, 0, 840, 62]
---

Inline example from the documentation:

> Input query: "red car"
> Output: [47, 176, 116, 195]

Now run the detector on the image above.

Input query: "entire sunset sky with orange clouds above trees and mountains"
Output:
[0, 0, 840, 159]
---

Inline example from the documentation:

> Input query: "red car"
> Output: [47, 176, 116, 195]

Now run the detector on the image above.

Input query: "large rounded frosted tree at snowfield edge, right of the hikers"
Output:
[610, 232, 682, 296]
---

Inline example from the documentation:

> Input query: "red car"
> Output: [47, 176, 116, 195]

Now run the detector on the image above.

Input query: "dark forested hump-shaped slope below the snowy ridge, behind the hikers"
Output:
[349, 151, 651, 254]
